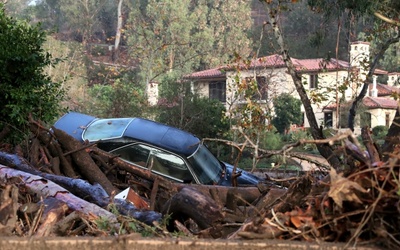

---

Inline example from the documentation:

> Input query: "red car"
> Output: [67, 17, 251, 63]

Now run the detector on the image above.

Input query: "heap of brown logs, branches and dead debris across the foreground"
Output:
[0, 118, 400, 249]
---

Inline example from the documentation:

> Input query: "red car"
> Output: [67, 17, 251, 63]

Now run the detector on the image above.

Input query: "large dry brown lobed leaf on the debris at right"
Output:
[328, 168, 368, 208]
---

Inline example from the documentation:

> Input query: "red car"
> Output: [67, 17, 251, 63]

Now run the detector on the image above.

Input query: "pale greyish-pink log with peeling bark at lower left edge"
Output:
[0, 165, 117, 223]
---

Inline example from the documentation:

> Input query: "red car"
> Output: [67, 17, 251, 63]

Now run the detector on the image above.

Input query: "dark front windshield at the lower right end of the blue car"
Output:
[188, 144, 222, 185]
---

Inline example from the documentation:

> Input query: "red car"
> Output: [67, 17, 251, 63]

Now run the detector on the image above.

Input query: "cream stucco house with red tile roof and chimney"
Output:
[187, 42, 400, 132]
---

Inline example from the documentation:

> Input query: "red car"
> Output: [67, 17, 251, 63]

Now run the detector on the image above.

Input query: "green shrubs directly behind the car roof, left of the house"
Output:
[158, 76, 229, 138]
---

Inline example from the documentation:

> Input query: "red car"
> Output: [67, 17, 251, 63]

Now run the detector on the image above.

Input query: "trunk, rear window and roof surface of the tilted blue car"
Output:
[54, 112, 200, 156]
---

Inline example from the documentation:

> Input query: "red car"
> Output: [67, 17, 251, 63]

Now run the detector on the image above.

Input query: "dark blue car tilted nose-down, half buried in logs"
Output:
[54, 112, 261, 186]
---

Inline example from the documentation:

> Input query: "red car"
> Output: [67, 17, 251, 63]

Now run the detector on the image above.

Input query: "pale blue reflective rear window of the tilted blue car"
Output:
[83, 118, 132, 141]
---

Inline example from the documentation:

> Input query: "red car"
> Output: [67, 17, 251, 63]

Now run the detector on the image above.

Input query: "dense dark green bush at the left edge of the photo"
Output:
[0, 5, 65, 143]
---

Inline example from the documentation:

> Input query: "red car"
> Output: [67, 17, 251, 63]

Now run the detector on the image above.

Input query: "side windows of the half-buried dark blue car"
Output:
[111, 143, 196, 183]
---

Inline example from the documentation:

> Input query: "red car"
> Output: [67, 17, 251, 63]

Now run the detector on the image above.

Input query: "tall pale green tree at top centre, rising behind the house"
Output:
[127, 0, 251, 84]
